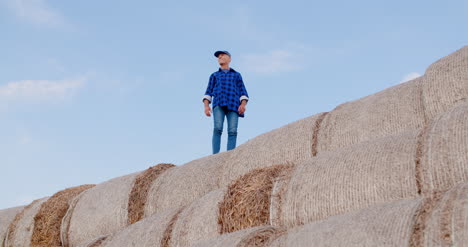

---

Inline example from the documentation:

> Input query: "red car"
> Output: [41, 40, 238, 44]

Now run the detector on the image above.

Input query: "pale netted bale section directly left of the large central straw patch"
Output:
[169, 189, 226, 247]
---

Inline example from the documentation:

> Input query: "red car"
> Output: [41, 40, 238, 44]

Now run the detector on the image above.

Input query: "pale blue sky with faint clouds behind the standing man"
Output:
[0, 0, 468, 209]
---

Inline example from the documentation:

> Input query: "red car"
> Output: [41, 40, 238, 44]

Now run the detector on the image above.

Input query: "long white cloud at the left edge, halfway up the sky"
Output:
[0, 78, 86, 101]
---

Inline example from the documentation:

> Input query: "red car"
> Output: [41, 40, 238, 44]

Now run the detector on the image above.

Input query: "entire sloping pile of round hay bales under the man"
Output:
[0, 46, 468, 247]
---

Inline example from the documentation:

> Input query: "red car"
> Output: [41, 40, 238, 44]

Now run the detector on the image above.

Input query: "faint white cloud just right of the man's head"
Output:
[240, 50, 302, 74]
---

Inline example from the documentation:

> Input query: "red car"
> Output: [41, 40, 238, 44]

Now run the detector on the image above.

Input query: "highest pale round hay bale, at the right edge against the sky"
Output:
[422, 46, 468, 119]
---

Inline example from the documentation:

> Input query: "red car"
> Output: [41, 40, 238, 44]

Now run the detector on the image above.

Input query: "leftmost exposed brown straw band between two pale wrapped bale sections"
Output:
[31, 185, 94, 246]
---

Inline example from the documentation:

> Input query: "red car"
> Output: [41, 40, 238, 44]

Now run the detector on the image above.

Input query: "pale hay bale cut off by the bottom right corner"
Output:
[417, 183, 468, 247]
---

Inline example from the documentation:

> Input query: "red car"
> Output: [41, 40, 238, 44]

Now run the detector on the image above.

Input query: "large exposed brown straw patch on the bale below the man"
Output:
[218, 165, 293, 233]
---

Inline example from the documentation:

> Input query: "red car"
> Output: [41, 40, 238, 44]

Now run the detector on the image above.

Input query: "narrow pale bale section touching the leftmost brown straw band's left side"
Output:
[5, 197, 49, 247]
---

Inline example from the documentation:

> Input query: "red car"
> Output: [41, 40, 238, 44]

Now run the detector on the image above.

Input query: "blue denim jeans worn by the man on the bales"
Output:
[213, 106, 239, 154]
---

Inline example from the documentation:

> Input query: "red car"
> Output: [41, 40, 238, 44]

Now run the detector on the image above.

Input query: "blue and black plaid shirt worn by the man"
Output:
[203, 68, 249, 117]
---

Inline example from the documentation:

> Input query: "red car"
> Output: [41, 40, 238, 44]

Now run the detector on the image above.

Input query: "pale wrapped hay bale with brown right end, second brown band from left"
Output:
[61, 163, 174, 247]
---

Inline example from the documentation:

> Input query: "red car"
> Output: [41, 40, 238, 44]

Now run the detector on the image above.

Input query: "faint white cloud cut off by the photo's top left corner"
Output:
[4, 0, 65, 26]
